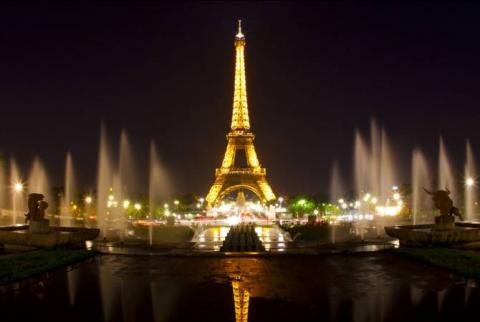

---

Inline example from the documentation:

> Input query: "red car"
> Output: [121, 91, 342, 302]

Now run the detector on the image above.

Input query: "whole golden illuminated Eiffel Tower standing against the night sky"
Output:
[206, 20, 275, 207]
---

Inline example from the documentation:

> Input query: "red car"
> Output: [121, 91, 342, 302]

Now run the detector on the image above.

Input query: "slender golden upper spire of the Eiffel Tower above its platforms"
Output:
[230, 20, 250, 130]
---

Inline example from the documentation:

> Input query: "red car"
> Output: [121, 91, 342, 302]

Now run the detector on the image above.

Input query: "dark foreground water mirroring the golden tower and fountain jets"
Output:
[0, 253, 480, 322]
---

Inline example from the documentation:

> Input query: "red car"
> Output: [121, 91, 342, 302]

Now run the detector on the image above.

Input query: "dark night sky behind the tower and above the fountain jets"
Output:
[0, 2, 480, 194]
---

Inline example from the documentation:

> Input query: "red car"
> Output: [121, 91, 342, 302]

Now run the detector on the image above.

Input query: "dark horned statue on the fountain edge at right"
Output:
[423, 188, 463, 229]
